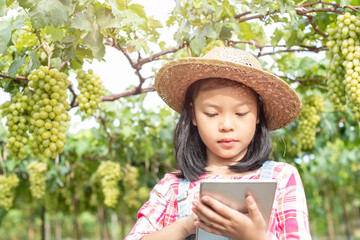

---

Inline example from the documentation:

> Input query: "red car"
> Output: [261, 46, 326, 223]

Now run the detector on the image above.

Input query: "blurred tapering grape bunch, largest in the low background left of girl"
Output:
[92, 161, 122, 208]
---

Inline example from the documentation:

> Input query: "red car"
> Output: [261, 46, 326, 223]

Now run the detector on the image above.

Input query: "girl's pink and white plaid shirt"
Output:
[125, 162, 311, 240]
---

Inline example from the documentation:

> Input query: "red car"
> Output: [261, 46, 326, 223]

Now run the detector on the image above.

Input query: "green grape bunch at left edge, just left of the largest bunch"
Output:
[1, 89, 31, 159]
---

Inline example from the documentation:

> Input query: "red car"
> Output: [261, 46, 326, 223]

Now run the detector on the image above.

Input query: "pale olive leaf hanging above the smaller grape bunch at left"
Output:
[83, 23, 105, 61]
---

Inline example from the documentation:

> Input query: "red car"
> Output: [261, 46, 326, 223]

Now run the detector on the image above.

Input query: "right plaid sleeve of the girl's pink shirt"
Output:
[273, 165, 311, 240]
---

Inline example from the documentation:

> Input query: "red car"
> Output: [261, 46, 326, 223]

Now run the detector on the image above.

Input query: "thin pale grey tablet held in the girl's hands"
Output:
[196, 179, 277, 240]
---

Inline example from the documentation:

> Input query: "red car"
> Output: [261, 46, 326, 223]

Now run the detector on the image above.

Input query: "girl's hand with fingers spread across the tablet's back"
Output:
[192, 194, 267, 240]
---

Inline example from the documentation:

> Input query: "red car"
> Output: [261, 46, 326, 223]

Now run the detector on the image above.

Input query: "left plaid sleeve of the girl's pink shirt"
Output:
[124, 176, 176, 240]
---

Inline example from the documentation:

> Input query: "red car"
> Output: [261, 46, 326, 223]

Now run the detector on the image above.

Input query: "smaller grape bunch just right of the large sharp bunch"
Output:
[76, 69, 104, 115]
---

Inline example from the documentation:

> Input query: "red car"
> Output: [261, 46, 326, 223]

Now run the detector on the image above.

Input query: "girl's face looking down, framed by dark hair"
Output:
[192, 81, 259, 165]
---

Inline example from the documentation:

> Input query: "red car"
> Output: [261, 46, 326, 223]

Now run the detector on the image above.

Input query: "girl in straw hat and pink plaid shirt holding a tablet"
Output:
[126, 48, 311, 240]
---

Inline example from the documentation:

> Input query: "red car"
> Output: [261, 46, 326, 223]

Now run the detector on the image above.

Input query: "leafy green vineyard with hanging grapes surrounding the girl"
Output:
[0, 0, 360, 240]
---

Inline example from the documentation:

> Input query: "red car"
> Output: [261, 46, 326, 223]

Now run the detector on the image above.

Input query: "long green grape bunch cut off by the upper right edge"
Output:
[326, 12, 360, 121]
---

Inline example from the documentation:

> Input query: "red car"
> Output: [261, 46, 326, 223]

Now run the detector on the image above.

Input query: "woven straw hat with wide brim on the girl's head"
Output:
[155, 47, 301, 130]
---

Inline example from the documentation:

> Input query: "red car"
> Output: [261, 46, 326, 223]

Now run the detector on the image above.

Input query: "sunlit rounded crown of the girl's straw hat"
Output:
[203, 47, 262, 70]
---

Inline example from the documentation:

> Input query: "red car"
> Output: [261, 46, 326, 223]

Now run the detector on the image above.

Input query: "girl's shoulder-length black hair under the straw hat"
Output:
[173, 79, 272, 182]
